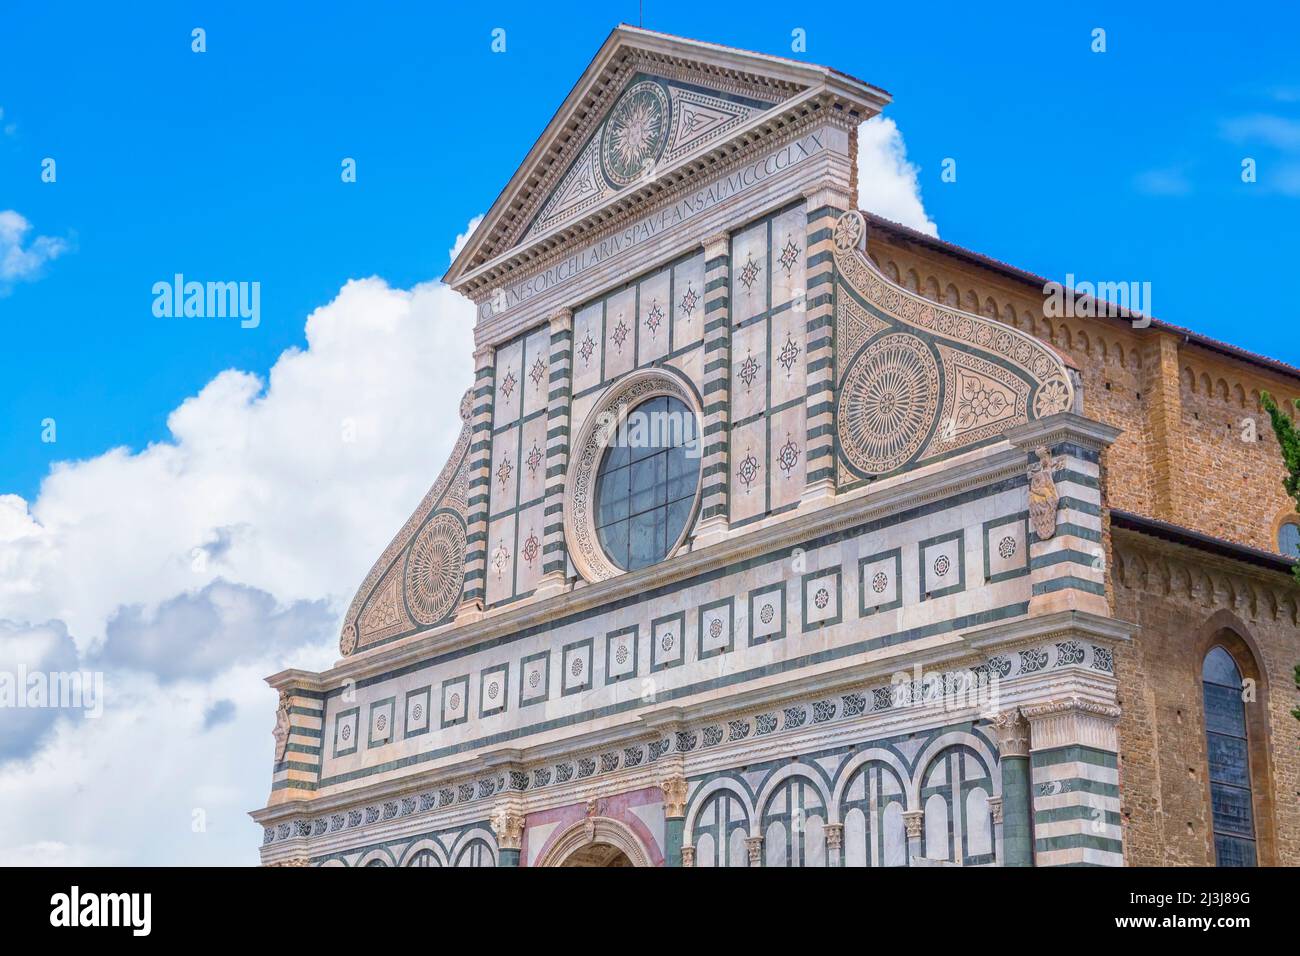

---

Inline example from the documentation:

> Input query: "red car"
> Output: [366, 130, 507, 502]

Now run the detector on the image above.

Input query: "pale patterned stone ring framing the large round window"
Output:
[564, 368, 703, 581]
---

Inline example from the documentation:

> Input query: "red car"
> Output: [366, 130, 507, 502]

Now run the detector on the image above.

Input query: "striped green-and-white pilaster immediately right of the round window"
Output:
[694, 233, 731, 548]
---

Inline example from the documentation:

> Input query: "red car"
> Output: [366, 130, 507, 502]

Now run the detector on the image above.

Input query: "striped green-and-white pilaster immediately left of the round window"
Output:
[537, 308, 573, 596]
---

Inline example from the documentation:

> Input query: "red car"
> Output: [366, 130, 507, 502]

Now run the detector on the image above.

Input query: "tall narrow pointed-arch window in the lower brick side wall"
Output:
[1201, 646, 1256, 866]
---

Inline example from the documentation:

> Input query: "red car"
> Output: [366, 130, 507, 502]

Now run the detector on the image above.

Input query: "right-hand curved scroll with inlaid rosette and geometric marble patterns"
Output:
[835, 212, 1079, 485]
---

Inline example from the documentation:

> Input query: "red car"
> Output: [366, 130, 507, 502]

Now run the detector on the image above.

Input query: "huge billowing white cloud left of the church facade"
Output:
[0, 235, 473, 864]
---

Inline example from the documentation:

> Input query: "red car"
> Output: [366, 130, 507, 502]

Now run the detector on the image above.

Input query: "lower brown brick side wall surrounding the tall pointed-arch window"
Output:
[1114, 531, 1300, 866]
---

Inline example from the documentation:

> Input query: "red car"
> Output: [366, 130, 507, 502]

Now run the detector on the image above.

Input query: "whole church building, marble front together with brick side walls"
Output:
[252, 27, 1300, 866]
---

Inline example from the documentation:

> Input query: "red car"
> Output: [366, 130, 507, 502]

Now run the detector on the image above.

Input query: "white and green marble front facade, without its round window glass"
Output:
[254, 27, 1126, 866]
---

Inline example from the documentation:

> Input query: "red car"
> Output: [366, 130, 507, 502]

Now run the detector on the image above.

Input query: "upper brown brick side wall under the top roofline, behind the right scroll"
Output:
[867, 232, 1300, 550]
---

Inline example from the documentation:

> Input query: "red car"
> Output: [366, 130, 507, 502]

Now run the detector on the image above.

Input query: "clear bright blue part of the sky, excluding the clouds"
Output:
[0, 1, 1300, 498]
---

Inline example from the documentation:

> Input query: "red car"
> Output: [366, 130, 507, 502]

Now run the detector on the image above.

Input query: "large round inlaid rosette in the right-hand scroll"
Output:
[839, 333, 939, 475]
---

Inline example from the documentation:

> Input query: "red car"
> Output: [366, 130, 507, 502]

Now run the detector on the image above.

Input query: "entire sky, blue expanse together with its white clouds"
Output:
[0, 0, 1300, 865]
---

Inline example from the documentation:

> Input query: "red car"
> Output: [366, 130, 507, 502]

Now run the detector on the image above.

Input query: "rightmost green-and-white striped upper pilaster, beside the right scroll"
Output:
[802, 180, 853, 505]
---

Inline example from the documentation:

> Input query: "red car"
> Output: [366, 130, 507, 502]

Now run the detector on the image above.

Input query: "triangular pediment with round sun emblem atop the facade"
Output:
[445, 26, 888, 287]
